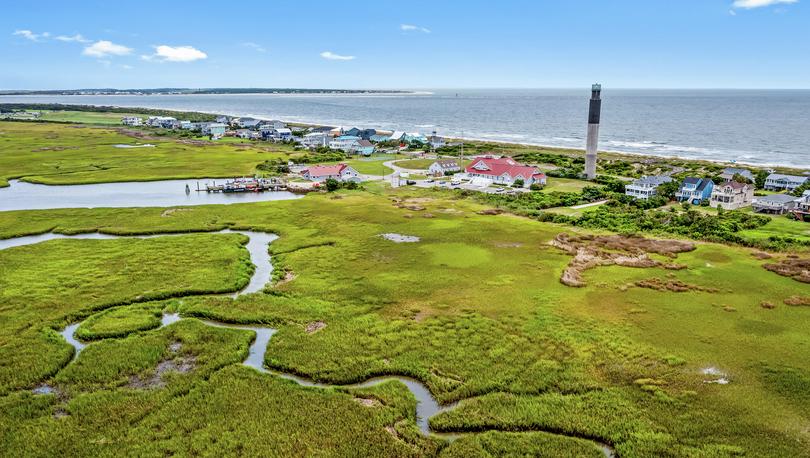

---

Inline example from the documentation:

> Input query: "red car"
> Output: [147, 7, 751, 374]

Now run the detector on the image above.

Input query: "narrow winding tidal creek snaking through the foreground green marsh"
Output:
[0, 217, 615, 457]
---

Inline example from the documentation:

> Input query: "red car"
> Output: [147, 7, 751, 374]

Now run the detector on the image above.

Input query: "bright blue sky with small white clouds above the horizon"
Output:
[0, 0, 810, 89]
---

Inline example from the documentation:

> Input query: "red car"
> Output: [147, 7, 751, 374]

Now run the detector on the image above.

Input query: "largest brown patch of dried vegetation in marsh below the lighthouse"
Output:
[549, 233, 695, 287]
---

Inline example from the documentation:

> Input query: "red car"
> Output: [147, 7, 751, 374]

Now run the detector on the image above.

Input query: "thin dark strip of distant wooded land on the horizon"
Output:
[0, 87, 409, 95]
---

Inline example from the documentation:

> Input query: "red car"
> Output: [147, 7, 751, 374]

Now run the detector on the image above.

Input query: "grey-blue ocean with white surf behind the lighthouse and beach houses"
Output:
[0, 87, 810, 168]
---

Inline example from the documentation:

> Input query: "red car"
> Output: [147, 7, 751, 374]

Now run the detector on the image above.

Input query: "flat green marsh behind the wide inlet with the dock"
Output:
[0, 122, 292, 186]
